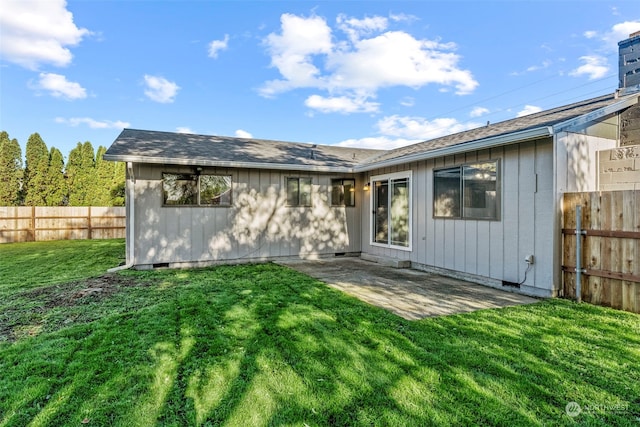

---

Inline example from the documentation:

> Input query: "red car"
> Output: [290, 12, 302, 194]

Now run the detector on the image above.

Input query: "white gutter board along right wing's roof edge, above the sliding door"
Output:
[354, 126, 553, 172]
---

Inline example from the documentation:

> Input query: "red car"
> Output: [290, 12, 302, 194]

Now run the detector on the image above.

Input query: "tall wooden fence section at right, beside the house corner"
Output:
[562, 190, 640, 313]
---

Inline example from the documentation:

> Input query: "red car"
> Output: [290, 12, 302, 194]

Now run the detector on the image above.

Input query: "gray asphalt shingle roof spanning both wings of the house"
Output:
[104, 94, 638, 172]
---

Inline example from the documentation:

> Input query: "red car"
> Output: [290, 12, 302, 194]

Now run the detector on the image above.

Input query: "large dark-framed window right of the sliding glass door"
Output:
[433, 161, 500, 220]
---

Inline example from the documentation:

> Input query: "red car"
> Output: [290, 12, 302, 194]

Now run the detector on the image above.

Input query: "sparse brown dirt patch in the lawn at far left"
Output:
[0, 274, 151, 342]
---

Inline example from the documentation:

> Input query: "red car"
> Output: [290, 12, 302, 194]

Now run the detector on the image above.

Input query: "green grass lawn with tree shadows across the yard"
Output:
[0, 240, 640, 427]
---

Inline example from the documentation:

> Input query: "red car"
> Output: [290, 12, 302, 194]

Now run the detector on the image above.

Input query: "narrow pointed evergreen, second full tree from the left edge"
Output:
[22, 133, 49, 206]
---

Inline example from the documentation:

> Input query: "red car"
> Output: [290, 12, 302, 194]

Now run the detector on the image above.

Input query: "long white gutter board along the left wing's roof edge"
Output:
[102, 154, 354, 173]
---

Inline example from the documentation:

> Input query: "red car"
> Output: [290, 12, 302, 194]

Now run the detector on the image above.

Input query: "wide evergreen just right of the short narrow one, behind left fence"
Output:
[65, 141, 97, 206]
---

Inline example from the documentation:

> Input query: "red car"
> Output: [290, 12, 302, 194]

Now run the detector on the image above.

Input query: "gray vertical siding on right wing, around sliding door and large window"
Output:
[362, 138, 556, 296]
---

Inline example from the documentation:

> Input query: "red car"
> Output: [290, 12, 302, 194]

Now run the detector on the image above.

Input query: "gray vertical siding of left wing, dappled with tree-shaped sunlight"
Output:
[127, 163, 363, 267]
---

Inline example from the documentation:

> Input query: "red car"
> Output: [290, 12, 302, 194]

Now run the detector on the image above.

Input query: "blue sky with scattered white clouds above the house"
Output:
[0, 0, 640, 156]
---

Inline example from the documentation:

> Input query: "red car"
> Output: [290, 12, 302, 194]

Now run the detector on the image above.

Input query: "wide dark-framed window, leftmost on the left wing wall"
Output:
[162, 173, 231, 206]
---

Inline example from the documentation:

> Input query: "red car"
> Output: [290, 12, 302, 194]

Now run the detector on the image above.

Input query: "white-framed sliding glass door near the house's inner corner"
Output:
[370, 171, 412, 250]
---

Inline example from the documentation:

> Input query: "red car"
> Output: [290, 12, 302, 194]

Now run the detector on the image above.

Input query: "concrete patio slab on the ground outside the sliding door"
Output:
[278, 257, 539, 320]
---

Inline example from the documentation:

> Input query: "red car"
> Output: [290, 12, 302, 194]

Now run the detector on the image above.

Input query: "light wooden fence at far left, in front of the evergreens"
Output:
[0, 206, 126, 243]
